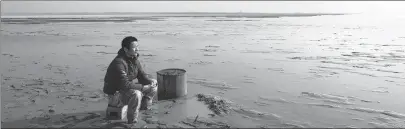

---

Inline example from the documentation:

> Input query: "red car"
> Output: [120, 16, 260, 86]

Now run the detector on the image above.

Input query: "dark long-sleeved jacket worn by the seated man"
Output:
[103, 49, 151, 95]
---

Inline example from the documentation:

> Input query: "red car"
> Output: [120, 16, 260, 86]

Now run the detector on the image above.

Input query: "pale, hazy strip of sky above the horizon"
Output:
[1, 1, 405, 13]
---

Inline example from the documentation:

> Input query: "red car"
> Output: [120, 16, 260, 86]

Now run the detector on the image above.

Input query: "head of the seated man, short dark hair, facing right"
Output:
[121, 36, 139, 58]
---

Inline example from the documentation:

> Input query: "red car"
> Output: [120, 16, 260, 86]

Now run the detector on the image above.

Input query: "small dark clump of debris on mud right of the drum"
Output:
[197, 94, 231, 115]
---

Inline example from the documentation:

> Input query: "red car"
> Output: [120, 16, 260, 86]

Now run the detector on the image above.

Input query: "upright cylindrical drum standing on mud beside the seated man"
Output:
[157, 68, 187, 100]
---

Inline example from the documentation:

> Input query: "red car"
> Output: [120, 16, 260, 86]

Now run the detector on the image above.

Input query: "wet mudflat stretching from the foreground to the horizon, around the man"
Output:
[0, 14, 405, 128]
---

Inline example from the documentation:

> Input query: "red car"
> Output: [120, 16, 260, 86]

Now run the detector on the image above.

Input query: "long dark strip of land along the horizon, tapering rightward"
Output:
[1, 12, 346, 24]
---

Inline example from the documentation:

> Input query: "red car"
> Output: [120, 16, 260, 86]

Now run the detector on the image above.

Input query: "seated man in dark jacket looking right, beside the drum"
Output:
[103, 36, 157, 124]
